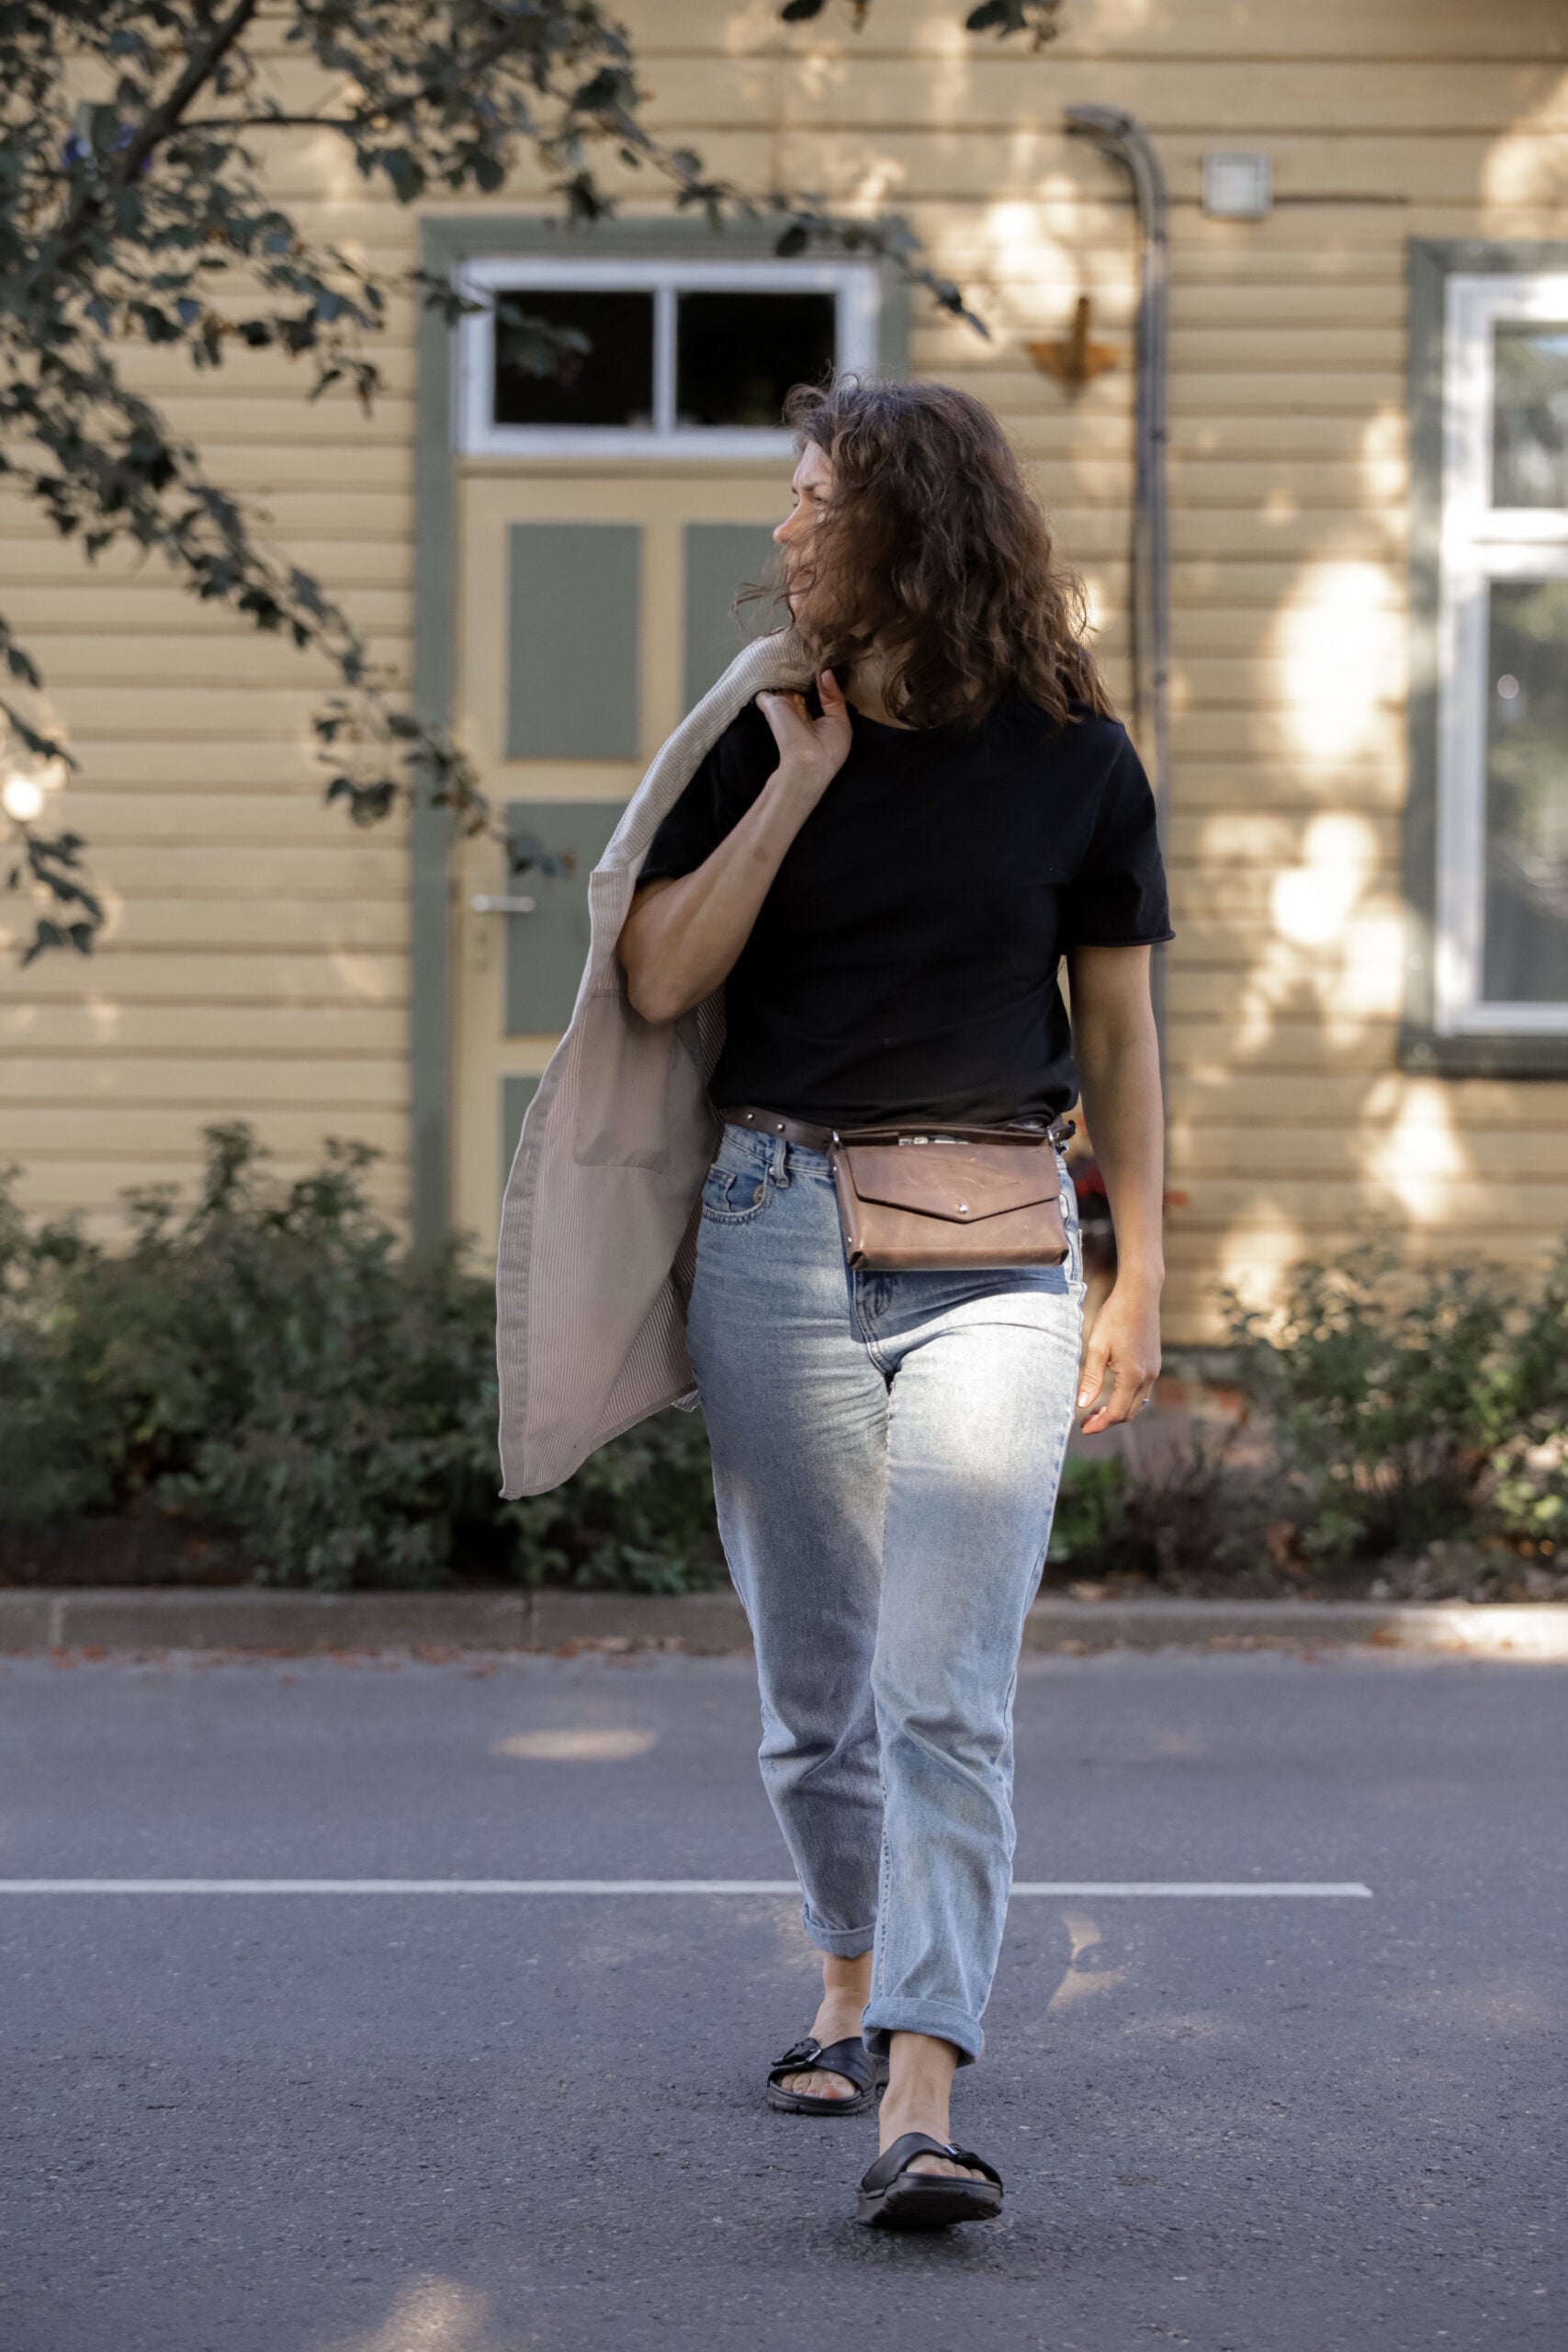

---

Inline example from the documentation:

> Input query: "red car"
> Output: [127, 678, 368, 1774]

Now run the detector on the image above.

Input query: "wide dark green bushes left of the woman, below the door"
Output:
[0, 1122, 724, 1592]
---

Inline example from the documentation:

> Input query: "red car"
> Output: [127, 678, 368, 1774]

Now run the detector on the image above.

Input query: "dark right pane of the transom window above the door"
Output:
[674, 294, 837, 430]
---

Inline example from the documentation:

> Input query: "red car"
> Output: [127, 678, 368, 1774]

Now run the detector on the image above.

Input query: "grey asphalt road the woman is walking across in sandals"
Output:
[0, 1654, 1568, 2352]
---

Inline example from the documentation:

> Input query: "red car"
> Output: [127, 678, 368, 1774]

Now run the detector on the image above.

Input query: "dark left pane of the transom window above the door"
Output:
[496, 287, 653, 425]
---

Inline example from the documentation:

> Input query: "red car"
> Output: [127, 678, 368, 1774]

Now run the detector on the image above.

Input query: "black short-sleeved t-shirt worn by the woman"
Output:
[639, 694, 1173, 1126]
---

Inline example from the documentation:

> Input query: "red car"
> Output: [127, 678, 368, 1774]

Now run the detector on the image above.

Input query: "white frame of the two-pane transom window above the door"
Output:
[456, 254, 879, 458]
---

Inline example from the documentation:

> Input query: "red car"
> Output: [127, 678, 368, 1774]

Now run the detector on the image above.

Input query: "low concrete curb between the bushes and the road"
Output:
[0, 1585, 1568, 1660]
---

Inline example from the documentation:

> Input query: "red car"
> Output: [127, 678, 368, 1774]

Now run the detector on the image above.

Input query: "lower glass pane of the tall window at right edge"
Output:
[1481, 581, 1568, 1004]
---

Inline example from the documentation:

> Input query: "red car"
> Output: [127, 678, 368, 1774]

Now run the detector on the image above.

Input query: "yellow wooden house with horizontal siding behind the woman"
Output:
[0, 0, 1568, 1345]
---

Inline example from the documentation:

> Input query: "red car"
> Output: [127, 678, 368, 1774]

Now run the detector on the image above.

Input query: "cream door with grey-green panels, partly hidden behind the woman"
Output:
[451, 458, 790, 1253]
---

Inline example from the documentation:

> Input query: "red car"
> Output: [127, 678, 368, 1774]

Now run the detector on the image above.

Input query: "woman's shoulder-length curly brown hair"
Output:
[766, 377, 1112, 727]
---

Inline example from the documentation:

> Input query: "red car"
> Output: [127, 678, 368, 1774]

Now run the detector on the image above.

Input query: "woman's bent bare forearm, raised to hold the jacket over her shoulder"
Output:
[616, 769, 813, 1021]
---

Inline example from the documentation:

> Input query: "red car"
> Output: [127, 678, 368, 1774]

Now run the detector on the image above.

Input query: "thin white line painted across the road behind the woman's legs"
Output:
[0, 1879, 1373, 1898]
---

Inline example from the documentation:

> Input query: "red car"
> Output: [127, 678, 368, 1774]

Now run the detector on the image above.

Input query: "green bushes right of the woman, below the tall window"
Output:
[1051, 1242, 1568, 1590]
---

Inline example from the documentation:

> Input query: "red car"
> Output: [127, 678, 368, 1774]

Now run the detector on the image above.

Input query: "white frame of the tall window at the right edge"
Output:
[1432, 270, 1568, 1037]
